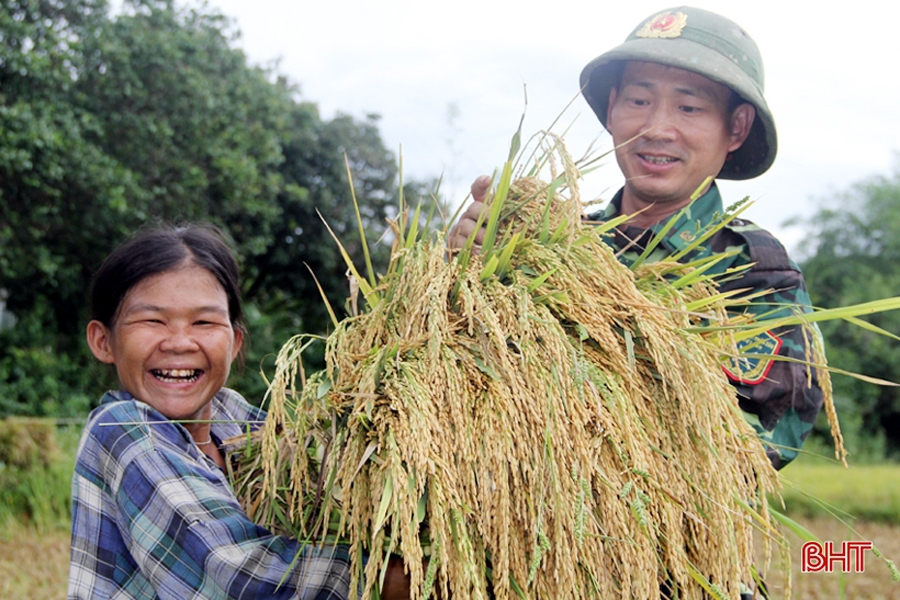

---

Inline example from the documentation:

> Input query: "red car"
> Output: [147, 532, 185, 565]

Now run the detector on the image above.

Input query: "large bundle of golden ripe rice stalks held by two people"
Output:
[235, 134, 827, 600]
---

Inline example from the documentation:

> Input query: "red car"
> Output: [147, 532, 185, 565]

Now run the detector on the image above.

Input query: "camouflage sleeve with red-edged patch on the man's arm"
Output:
[722, 230, 823, 469]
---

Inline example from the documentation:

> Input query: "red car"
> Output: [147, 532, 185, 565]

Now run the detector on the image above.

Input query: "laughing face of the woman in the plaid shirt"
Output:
[87, 264, 243, 420]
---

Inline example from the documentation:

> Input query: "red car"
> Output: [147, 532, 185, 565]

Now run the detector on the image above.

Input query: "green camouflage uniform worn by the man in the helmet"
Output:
[587, 184, 822, 469]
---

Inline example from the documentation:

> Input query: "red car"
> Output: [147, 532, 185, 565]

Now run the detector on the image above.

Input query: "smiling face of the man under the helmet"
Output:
[606, 61, 756, 210]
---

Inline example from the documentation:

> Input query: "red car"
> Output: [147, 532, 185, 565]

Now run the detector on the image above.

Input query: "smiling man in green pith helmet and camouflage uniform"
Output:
[450, 7, 822, 468]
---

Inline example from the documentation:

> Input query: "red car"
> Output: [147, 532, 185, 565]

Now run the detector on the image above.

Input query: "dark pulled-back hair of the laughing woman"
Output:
[90, 223, 246, 333]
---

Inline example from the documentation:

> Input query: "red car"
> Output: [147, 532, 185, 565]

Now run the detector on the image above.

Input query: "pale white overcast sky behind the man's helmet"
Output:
[200, 0, 900, 254]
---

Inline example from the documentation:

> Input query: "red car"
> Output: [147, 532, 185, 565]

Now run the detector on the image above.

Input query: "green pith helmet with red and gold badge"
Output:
[581, 6, 777, 179]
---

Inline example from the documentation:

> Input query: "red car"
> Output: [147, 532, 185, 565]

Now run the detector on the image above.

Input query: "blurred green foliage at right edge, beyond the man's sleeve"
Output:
[802, 157, 900, 458]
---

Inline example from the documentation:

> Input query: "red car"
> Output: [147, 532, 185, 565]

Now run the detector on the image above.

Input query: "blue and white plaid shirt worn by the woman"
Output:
[68, 389, 350, 600]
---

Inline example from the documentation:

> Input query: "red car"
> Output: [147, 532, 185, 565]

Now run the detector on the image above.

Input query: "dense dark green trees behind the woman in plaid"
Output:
[0, 0, 442, 415]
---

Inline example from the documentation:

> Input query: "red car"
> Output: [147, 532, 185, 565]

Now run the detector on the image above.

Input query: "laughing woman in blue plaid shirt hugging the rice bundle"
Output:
[68, 226, 409, 600]
